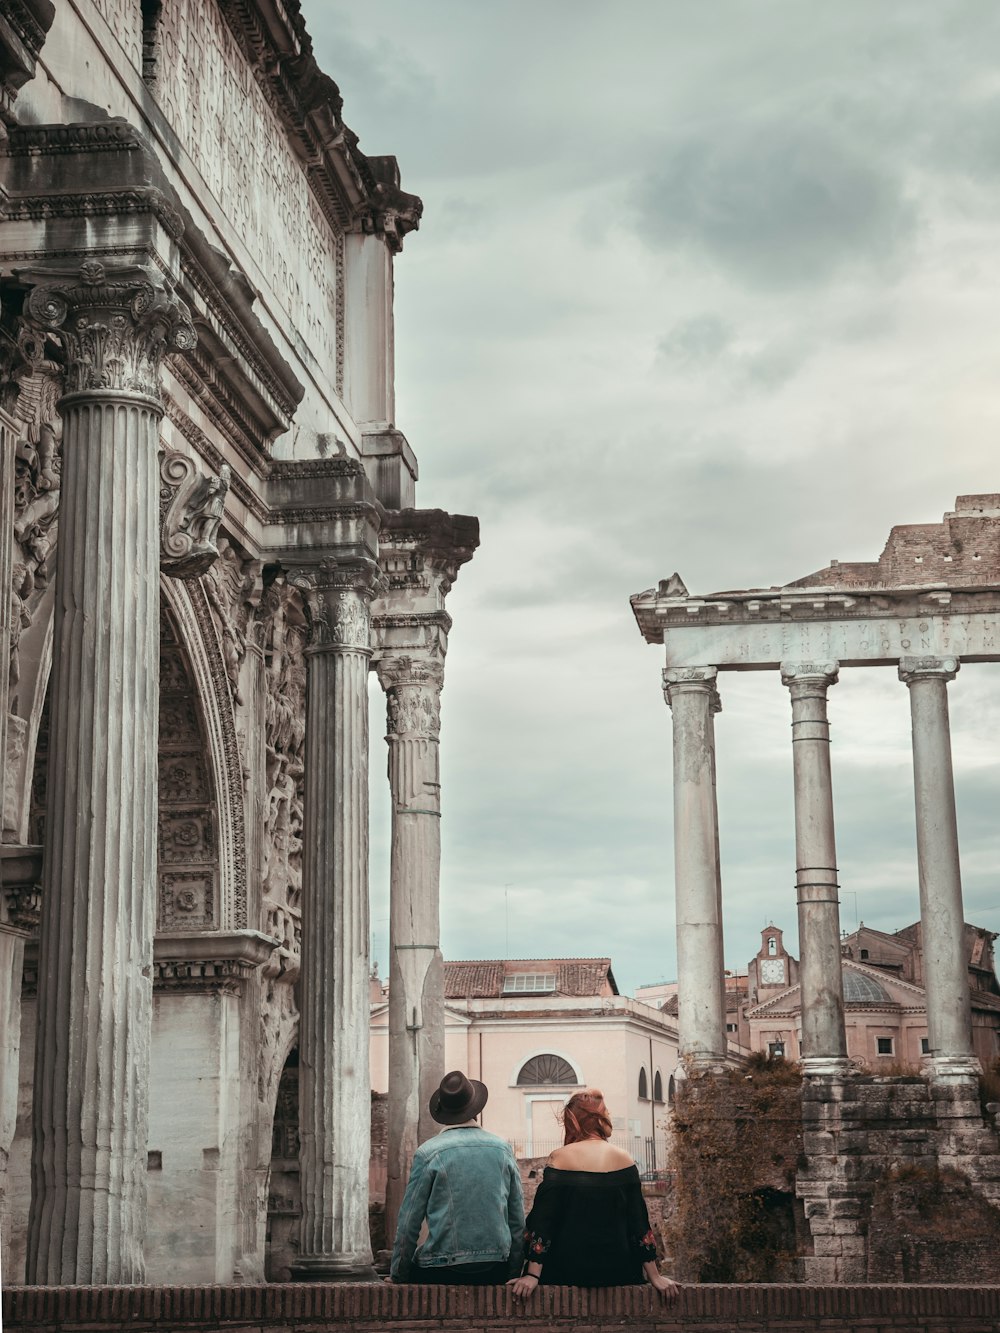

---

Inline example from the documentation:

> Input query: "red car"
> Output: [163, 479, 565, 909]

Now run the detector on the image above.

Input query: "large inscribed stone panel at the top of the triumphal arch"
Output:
[156, 0, 343, 381]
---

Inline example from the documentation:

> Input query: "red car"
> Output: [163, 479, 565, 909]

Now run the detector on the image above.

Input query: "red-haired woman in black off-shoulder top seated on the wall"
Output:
[508, 1088, 680, 1300]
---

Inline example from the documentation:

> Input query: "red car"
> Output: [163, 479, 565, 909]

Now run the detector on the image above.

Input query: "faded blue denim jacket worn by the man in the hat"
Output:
[391, 1126, 524, 1282]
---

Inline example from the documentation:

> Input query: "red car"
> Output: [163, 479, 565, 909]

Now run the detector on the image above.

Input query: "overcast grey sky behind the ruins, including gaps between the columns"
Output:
[303, 0, 1000, 990]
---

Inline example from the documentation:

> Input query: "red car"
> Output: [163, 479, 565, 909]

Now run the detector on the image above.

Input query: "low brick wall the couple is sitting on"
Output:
[3, 1284, 1000, 1333]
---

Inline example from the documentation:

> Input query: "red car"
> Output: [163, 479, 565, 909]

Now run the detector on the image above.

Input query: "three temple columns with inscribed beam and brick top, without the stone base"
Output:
[632, 495, 1000, 1084]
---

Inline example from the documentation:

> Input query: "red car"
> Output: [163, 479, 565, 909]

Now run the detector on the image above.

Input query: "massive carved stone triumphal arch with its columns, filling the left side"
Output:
[0, 0, 479, 1284]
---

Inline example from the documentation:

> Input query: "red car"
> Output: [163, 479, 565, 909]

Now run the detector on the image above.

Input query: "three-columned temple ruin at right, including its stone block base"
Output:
[632, 495, 1000, 1281]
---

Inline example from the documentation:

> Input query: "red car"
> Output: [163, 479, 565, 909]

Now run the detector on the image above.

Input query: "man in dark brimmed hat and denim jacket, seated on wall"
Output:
[389, 1069, 524, 1286]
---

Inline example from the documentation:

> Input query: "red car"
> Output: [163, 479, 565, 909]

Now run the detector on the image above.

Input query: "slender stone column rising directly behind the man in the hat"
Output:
[377, 656, 444, 1240]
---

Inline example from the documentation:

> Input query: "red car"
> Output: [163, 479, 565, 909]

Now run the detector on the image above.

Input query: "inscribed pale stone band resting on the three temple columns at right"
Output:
[664, 613, 1000, 670]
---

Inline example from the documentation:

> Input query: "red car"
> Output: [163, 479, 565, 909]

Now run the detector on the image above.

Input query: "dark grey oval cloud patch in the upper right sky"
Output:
[635, 116, 917, 288]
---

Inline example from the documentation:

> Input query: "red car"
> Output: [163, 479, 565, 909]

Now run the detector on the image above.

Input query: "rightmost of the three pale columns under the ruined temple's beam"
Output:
[899, 657, 980, 1082]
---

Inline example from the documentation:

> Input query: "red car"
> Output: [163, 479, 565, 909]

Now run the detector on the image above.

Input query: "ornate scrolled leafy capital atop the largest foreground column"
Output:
[17, 259, 197, 399]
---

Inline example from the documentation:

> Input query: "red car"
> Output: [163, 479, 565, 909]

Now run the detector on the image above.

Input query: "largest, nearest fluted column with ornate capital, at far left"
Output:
[23, 260, 195, 1285]
